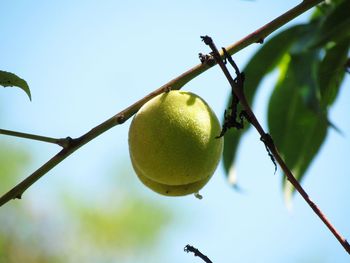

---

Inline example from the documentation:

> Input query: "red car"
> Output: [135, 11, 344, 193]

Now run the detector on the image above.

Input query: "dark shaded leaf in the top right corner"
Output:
[311, 0, 350, 48]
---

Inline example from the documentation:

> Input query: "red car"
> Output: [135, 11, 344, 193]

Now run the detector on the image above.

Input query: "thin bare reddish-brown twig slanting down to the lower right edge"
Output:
[202, 36, 350, 254]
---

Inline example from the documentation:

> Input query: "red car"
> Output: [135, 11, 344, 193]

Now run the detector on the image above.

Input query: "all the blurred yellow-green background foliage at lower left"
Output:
[0, 145, 172, 263]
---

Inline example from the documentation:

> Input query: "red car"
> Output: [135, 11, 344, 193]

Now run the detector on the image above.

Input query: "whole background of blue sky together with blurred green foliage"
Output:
[0, 0, 350, 263]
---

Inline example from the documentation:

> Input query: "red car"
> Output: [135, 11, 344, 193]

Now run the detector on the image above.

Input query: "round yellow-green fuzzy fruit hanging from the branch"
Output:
[129, 91, 223, 196]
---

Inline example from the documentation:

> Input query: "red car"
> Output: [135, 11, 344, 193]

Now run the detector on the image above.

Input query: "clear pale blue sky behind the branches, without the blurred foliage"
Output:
[0, 0, 350, 263]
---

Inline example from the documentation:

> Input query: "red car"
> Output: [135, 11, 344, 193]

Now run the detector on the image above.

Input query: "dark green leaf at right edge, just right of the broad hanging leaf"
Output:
[317, 38, 350, 108]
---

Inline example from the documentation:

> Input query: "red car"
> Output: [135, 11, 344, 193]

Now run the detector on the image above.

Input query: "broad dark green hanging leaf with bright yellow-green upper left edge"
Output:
[268, 51, 328, 202]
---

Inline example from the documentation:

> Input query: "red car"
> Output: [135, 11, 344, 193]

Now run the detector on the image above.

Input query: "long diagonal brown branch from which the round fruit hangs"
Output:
[0, 0, 323, 206]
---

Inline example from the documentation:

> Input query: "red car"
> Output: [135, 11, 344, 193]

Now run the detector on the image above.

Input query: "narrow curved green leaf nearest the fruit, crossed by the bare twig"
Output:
[223, 25, 306, 179]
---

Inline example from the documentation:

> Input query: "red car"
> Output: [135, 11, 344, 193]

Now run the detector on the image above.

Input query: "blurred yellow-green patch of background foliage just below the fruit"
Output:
[67, 192, 171, 253]
